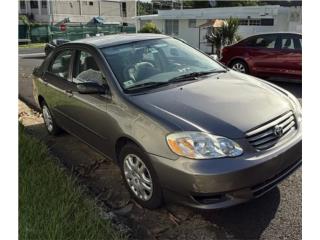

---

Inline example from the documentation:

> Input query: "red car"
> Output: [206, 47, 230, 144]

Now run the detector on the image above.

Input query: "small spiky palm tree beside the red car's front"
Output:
[206, 17, 240, 56]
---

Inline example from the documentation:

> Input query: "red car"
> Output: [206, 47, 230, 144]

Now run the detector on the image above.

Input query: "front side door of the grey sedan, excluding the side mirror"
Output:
[58, 49, 112, 155]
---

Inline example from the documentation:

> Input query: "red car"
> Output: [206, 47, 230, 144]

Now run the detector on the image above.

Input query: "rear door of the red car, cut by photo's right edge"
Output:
[279, 34, 302, 78]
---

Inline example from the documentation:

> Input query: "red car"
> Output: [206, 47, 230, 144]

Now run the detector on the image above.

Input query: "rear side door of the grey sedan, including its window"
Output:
[43, 48, 75, 129]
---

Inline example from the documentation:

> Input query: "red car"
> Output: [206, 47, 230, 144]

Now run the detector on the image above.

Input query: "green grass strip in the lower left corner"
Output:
[19, 125, 125, 240]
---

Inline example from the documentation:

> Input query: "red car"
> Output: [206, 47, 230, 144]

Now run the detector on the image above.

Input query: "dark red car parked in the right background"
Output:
[220, 33, 302, 81]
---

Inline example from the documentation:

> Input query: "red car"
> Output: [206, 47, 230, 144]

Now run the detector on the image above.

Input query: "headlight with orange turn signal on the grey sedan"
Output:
[167, 132, 243, 159]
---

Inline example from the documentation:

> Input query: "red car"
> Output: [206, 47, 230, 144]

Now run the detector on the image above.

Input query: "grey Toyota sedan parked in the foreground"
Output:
[33, 34, 302, 209]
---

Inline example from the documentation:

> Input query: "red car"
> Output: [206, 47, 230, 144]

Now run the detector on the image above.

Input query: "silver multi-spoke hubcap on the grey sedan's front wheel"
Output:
[123, 154, 153, 201]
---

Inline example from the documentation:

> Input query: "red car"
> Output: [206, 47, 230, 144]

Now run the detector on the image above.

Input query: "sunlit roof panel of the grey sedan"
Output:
[65, 33, 169, 48]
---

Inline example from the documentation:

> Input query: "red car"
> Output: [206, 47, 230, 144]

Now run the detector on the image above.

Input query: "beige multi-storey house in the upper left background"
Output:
[19, 0, 136, 25]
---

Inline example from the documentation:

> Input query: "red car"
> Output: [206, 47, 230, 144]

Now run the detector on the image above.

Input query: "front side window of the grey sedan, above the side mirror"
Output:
[73, 51, 107, 86]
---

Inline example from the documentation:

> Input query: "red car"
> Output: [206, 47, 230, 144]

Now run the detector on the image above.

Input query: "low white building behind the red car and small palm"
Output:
[137, 5, 302, 52]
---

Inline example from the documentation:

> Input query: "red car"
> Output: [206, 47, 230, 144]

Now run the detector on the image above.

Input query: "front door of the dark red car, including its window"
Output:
[248, 34, 280, 77]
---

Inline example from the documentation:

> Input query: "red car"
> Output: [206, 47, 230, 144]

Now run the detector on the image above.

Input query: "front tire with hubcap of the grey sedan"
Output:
[119, 143, 163, 209]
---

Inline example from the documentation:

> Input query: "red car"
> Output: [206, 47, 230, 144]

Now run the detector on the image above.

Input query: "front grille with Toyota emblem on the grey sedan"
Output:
[246, 111, 296, 150]
